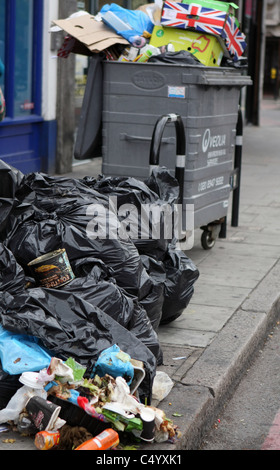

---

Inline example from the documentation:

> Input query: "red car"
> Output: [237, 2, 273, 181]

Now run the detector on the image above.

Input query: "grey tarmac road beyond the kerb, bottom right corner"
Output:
[201, 316, 280, 450]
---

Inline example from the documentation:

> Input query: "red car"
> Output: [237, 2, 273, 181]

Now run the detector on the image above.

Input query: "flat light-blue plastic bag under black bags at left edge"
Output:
[0, 326, 51, 375]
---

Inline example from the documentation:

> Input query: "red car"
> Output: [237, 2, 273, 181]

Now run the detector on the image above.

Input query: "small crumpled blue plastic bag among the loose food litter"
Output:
[92, 344, 134, 385]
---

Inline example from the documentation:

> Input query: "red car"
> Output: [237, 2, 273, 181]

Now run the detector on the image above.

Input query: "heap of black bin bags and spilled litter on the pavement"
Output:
[0, 161, 199, 449]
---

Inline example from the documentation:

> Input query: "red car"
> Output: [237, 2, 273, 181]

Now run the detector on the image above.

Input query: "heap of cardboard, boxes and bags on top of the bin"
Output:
[50, 0, 247, 67]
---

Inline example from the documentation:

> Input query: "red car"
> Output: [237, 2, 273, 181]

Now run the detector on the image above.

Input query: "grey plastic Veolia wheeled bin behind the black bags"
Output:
[102, 62, 251, 244]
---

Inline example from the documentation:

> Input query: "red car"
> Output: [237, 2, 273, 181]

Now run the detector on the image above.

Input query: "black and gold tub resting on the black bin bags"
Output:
[28, 248, 75, 288]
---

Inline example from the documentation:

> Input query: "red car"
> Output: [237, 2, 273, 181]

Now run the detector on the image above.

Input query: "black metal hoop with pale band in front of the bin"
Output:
[149, 114, 186, 204]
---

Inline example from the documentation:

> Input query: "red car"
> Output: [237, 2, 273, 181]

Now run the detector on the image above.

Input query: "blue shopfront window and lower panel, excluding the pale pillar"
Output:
[0, 0, 44, 173]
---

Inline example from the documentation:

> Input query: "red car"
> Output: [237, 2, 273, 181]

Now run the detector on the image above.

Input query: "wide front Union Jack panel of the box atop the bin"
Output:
[161, 0, 227, 36]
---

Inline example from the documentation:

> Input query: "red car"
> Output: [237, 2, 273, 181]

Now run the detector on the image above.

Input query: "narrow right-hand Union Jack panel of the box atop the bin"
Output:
[222, 16, 247, 61]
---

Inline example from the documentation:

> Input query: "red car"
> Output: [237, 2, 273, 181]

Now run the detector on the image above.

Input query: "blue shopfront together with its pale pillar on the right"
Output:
[0, 0, 57, 173]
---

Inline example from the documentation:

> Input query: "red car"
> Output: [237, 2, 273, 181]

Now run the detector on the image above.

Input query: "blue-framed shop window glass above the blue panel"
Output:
[0, 0, 43, 119]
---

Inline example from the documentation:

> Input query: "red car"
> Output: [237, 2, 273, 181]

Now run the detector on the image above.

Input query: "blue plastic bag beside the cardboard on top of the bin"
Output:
[100, 3, 154, 44]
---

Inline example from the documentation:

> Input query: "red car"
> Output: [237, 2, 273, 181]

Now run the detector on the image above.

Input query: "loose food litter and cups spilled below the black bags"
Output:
[0, 358, 177, 450]
